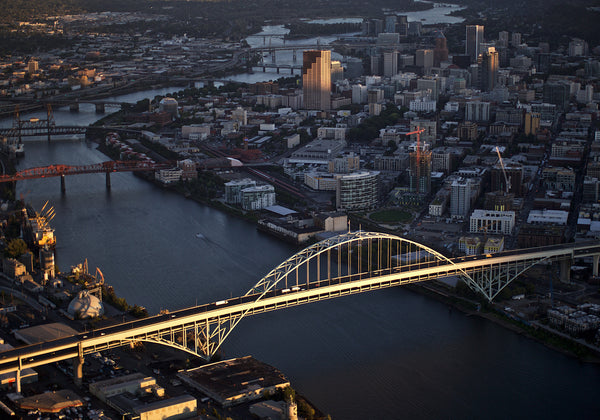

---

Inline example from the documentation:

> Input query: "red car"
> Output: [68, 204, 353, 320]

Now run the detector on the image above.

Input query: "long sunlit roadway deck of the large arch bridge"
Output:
[0, 241, 600, 380]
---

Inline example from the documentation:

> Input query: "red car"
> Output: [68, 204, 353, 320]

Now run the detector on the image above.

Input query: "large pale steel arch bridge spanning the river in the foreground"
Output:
[0, 231, 600, 389]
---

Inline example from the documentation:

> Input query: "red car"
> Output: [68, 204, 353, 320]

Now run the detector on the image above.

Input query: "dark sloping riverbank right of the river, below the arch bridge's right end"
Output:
[405, 282, 600, 364]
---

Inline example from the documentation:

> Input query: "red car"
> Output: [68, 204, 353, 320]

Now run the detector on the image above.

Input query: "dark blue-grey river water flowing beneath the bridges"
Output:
[4, 91, 600, 420]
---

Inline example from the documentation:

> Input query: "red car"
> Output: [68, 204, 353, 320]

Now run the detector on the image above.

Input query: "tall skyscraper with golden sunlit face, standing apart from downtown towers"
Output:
[302, 50, 331, 110]
